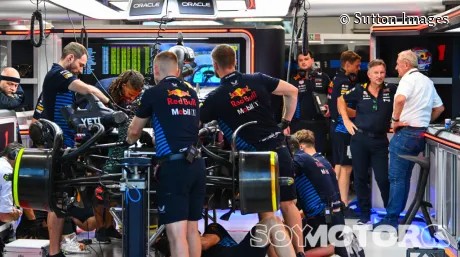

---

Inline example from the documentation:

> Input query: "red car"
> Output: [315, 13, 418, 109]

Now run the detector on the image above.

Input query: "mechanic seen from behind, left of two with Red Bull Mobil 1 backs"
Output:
[127, 52, 206, 257]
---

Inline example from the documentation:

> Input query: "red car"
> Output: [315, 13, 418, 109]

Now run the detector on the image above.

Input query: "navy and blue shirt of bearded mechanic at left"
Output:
[42, 63, 78, 147]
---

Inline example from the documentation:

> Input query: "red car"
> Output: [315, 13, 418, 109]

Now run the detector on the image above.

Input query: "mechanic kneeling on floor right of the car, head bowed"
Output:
[289, 129, 348, 256]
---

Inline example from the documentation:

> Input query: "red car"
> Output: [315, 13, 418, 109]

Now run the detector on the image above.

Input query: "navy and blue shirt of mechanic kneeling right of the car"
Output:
[294, 150, 340, 217]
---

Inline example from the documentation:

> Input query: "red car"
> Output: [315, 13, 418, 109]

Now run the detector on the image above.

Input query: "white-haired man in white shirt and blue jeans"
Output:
[374, 50, 444, 228]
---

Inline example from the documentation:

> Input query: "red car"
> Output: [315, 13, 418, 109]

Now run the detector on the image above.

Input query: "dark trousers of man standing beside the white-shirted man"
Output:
[350, 131, 390, 216]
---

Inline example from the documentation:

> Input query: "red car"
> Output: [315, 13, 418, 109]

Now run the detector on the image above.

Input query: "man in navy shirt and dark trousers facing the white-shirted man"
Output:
[337, 59, 396, 224]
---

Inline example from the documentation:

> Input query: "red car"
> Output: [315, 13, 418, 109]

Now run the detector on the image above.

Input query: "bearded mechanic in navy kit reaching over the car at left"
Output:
[42, 42, 109, 257]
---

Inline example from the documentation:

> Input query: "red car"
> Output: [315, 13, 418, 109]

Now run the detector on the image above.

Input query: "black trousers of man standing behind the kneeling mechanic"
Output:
[290, 119, 327, 155]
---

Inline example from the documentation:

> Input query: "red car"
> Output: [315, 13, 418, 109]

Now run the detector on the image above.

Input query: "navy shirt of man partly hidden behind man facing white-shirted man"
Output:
[328, 69, 354, 133]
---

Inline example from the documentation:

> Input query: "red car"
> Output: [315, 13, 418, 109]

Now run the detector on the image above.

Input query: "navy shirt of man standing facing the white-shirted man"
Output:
[343, 83, 396, 134]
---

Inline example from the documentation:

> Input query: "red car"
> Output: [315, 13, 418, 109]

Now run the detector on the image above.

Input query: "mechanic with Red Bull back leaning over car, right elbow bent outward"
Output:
[200, 45, 302, 252]
